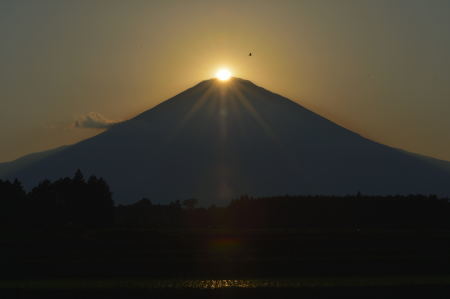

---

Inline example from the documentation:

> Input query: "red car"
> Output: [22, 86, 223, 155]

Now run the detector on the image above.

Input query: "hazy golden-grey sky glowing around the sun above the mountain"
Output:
[0, 0, 450, 161]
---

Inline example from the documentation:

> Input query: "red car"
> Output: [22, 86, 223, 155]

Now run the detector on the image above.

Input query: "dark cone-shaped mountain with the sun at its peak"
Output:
[0, 78, 450, 204]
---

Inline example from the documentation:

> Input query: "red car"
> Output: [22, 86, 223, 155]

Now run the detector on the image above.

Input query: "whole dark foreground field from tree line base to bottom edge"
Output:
[0, 229, 450, 298]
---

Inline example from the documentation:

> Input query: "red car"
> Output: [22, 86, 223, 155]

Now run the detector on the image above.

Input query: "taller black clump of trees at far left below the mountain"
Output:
[0, 170, 114, 228]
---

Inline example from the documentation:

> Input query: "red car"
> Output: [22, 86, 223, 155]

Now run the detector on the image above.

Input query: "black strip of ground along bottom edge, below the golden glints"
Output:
[6, 286, 450, 299]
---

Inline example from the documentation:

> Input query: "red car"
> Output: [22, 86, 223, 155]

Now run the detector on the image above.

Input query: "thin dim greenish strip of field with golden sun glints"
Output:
[4, 276, 450, 290]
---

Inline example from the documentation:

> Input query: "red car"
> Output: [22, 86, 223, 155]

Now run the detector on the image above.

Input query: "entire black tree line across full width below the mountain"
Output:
[0, 170, 450, 230]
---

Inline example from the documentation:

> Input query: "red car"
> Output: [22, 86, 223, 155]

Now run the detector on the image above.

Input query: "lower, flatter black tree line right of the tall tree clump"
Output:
[115, 194, 450, 230]
